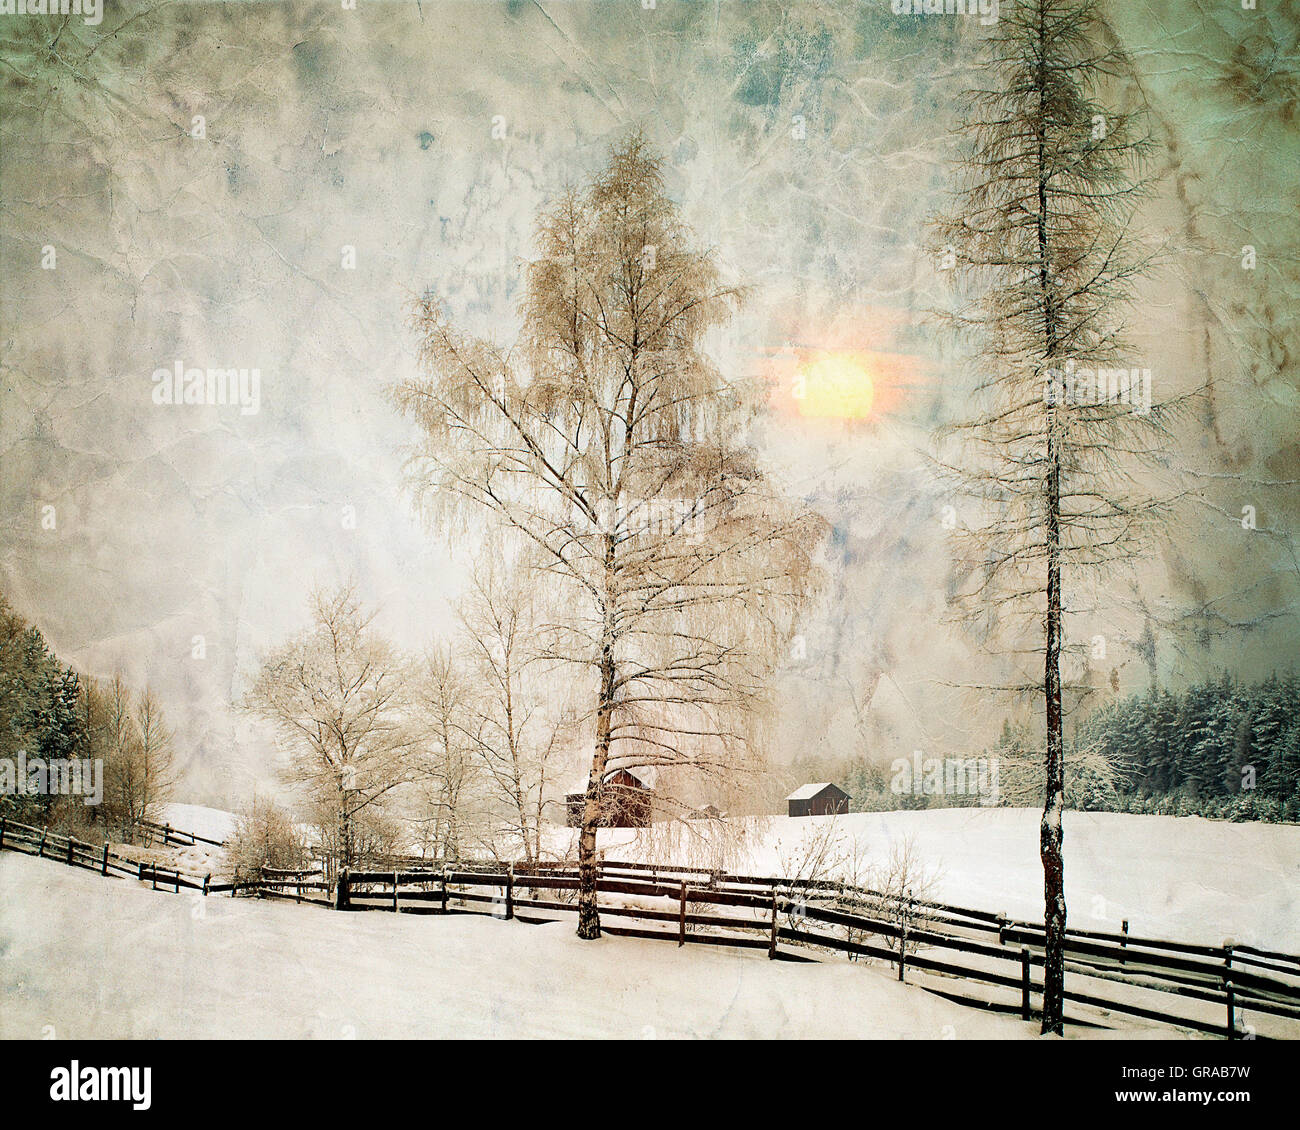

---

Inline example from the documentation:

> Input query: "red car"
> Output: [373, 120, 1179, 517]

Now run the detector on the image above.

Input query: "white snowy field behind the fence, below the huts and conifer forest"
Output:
[566, 809, 1300, 953]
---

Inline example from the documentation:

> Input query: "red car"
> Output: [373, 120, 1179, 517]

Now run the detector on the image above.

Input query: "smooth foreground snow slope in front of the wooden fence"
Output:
[0, 852, 1045, 1039]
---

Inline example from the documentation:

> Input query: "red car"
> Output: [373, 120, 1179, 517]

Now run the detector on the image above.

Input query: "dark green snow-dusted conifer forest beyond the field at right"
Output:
[790, 674, 1300, 821]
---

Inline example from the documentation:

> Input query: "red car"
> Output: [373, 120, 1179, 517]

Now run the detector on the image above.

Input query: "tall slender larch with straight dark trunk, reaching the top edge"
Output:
[937, 0, 1166, 1032]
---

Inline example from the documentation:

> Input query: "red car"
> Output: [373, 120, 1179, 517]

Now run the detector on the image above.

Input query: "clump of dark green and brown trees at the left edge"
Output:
[0, 594, 176, 839]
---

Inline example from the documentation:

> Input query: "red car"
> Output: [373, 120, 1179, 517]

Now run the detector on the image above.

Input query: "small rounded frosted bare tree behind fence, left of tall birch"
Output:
[244, 585, 412, 867]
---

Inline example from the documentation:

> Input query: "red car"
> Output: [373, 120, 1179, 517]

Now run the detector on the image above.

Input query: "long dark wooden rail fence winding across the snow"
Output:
[0, 819, 1300, 1039]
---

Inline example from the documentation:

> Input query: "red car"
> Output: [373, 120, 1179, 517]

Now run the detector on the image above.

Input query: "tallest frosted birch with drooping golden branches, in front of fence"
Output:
[395, 135, 818, 938]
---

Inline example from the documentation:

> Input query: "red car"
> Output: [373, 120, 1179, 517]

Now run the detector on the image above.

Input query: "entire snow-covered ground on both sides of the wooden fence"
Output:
[0, 805, 1300, 1039]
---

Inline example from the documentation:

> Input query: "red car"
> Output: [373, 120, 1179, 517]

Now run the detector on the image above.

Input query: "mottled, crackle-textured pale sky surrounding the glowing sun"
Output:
[0, 0, 1300, 789]
